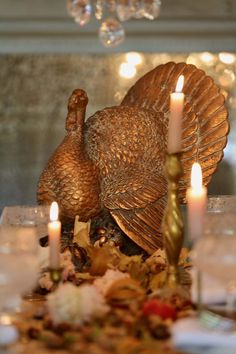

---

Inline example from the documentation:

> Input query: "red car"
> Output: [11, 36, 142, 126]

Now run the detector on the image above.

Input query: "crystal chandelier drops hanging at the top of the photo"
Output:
[67, 0, 161, 48]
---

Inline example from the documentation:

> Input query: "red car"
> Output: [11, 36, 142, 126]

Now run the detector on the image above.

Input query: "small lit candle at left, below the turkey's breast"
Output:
[48, 202, 61, 269]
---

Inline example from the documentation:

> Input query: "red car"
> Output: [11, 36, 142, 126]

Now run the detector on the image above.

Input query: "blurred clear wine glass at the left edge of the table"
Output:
[0, 225, 39, 344]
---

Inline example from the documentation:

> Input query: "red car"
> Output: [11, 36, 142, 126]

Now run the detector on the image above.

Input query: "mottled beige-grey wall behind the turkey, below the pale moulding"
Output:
[0, 53, 236, 213]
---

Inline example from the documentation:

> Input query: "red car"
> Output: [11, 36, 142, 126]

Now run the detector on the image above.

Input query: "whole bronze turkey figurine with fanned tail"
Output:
[38, 62, 229, 253]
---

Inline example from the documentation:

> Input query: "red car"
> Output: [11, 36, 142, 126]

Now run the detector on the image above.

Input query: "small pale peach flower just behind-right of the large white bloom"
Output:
[94, 269, 130, 295]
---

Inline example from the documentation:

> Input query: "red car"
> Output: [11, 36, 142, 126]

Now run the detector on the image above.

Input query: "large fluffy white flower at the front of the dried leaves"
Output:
[47, 283, 109, 325]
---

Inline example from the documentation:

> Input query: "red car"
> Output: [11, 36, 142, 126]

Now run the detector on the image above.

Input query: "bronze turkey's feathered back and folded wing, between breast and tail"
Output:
[85, 106, 167, 253]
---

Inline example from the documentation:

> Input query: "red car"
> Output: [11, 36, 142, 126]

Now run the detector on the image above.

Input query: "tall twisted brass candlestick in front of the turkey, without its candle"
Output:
[162, 152, 184, 290]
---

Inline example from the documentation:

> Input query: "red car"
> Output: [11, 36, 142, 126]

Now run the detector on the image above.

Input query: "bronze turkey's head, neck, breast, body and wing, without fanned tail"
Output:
[38, 89, 167, 253]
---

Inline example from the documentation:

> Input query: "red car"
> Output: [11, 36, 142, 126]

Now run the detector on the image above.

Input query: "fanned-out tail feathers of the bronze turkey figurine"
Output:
[121, 62, 229, 200]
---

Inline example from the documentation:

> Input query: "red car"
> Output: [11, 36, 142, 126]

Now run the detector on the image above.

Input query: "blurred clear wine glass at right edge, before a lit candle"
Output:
[192, 210, 236, 316]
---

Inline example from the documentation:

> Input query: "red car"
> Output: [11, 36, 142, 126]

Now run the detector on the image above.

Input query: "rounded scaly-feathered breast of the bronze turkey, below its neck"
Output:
[38, 133, 101, 223]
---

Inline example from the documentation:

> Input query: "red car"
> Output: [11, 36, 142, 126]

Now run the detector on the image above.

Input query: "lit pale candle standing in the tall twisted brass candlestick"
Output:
[167, 75, 184, 154]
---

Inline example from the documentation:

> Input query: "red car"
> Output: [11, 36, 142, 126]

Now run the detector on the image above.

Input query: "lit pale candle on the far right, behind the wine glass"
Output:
[187, 162, 207, 240]
